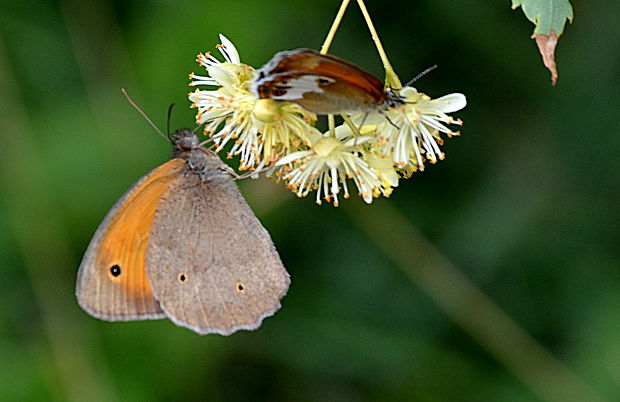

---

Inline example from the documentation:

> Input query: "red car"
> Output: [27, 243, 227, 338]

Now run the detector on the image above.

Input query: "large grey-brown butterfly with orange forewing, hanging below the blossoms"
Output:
[76, 128, 290, 335]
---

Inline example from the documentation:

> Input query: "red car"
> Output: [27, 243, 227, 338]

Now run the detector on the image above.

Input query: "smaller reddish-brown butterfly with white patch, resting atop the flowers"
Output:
[250, 48, 404, 114]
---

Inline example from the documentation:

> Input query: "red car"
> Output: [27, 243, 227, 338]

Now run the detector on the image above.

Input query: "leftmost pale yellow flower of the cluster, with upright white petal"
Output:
[189, 35, 316, 170]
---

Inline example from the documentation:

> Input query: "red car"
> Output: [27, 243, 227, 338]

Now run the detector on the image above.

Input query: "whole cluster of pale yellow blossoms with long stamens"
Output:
[189, 35, 466, 206]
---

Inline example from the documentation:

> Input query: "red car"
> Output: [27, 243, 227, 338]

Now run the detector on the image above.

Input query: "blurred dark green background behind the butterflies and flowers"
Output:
[0, 0, 620, 401]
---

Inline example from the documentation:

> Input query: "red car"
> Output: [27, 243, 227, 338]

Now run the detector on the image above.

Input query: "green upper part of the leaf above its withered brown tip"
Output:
[512, 0, 573, 36]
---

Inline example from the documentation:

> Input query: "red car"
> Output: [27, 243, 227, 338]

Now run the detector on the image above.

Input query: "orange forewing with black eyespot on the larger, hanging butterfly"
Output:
[76, 159, 185, 321]
